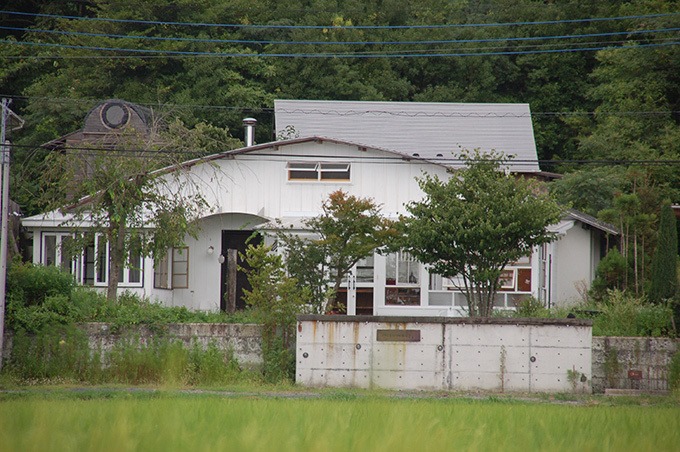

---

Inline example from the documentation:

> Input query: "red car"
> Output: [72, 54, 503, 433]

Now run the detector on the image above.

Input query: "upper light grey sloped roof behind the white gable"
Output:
[274, 100, 540, 173]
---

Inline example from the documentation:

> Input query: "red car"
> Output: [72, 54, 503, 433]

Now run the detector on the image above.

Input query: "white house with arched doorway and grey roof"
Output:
[23, 101, 616, 316]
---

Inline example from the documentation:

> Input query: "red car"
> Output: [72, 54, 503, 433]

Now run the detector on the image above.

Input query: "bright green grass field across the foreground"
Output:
[0, 391, 680, 452]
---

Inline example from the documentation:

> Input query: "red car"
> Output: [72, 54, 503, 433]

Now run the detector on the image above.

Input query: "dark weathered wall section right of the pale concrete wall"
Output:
[592, 337, 678, 393]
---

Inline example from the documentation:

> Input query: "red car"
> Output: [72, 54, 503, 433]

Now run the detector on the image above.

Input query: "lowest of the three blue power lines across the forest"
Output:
[5, 38, 680, 58]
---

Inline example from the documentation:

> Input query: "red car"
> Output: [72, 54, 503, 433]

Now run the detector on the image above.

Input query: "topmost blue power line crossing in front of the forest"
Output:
[0, 10, 680, 30]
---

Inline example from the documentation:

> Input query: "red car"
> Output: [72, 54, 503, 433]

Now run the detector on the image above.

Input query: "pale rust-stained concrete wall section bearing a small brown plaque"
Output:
[296, 315, 592, 392]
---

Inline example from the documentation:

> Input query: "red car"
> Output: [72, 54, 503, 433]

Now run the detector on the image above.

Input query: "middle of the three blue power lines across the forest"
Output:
[0, 26, 680, 46]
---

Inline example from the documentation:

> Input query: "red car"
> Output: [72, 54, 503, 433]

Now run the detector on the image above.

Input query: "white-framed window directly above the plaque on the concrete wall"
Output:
[385, 251, 420, 306]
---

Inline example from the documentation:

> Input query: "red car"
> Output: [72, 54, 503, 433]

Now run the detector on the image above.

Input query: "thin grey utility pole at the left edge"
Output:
[0, 98, 24, 370]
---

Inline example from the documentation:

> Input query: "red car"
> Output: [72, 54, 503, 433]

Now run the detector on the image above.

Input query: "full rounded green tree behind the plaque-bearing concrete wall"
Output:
[403, 152, 564, 317]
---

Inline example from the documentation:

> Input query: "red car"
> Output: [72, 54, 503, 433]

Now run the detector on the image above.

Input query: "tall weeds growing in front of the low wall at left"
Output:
[4, 325, 242, 387]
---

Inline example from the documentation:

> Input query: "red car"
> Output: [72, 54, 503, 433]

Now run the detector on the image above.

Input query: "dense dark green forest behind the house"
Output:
[0, 0, 680, 293]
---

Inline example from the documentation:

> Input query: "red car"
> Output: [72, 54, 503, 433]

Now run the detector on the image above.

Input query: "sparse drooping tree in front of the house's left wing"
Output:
[43, 116, 237, 299]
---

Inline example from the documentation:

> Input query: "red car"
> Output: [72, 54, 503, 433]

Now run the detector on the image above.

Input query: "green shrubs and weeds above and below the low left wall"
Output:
[3, 262, 257, 385]
